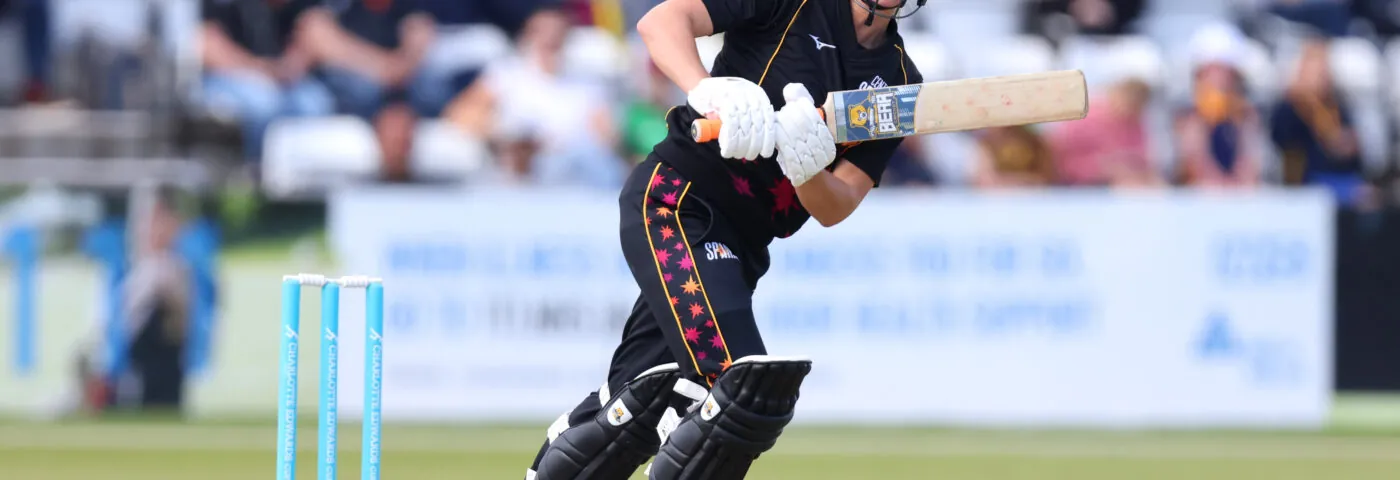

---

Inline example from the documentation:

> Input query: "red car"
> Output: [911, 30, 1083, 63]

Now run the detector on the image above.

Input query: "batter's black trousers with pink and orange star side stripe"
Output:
[535, 155, 767, 467]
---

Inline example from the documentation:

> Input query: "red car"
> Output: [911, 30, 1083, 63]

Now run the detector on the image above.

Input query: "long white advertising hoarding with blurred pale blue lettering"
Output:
[322, 190, 1333, 427]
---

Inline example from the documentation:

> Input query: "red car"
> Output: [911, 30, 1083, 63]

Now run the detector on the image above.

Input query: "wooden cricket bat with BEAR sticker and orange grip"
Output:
[690, 70, 1089, 143]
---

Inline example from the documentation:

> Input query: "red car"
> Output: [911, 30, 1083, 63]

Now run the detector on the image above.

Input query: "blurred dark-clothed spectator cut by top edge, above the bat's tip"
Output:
[1022, 0, 1142, 42]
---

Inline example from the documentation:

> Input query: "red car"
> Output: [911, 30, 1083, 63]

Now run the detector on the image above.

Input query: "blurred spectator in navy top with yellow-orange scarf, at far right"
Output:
[1270, 41, 1365, 206]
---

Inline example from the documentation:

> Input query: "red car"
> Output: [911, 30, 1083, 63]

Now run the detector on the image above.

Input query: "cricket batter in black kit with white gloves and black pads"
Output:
[525, 0, 924, 480]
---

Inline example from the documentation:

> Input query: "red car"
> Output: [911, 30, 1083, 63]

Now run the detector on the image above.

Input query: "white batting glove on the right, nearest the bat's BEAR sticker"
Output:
[777, 84, 836, 186]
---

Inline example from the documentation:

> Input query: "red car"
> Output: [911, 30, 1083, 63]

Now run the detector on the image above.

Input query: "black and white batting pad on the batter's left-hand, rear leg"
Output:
[533, 364, 679, 480]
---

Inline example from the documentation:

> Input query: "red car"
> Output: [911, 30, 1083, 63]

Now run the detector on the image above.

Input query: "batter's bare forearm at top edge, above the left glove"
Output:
[637, 0, 714, 91]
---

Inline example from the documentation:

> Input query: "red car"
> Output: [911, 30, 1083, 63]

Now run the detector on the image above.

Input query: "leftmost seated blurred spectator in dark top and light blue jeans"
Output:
[199, 0, 335, 165]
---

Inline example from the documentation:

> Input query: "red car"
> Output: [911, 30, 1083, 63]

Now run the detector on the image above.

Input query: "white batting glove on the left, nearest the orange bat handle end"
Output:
[686, 77, 777, 160]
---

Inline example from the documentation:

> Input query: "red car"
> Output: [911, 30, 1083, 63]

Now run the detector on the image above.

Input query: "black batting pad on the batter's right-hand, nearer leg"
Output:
[648, 355, 812, 480]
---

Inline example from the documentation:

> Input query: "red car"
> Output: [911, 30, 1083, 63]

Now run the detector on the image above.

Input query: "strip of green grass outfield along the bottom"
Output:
[0, 421, 1400, 480]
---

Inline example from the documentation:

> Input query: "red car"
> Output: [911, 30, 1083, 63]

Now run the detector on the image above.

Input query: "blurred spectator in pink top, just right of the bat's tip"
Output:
[1050, 78, 1161, 186]
